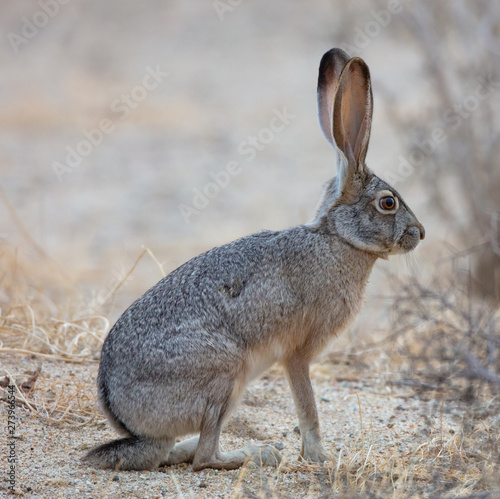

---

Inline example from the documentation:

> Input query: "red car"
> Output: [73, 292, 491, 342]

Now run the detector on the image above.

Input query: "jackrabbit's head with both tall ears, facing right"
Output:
[313, 49, 425, 258]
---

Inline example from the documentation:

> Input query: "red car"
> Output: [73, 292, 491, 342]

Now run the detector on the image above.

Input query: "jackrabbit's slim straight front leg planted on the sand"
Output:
[284, 353, 328, 463]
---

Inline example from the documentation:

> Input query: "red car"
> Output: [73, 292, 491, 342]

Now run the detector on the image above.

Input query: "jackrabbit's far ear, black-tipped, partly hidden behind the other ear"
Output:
[318, 49, 349, 147]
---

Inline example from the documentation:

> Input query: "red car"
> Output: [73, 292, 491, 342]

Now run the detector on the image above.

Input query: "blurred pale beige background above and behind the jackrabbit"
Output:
[0, 0, 500, 330]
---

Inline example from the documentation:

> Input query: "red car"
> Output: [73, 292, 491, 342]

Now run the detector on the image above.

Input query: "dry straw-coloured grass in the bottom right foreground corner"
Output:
[221, 376, 500, 498]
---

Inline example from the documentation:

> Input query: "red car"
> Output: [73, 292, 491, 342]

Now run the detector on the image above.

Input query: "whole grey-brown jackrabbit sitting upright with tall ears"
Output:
[84, 49, 424, 471]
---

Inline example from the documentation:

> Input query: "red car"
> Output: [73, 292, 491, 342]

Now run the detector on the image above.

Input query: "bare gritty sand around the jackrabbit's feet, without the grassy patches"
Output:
[0, 355, 474, 498]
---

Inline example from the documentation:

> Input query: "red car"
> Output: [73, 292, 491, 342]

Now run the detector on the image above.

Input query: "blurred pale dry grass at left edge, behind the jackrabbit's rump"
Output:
[0, 245, 109, 363]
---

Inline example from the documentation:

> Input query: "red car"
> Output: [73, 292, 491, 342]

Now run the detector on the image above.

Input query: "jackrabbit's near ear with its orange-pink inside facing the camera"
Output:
[332, 57, 373, 170]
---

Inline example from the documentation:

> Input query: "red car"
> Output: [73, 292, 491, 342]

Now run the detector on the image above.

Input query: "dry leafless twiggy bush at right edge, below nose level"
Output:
[393, 275, 500, 402]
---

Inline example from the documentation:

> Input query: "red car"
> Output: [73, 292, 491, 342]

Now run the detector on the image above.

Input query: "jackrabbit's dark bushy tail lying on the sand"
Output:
[83, 436, 175, 470]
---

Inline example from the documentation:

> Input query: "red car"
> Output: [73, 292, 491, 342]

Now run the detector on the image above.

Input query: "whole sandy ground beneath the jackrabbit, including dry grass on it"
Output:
[1, 354, 498, 498]
